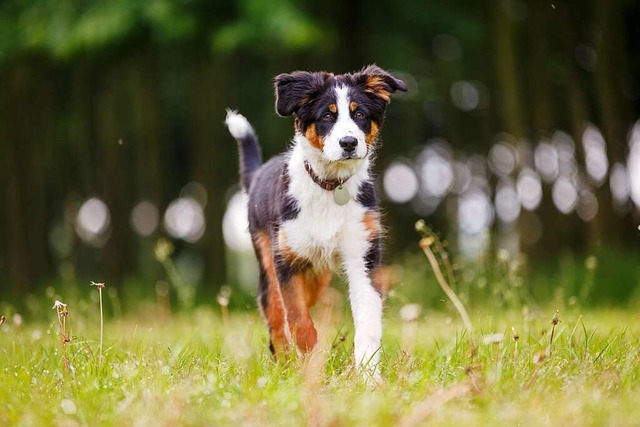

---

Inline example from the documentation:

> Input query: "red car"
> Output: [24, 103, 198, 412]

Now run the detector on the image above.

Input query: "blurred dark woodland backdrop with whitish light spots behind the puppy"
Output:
[0, 0, 640, 308]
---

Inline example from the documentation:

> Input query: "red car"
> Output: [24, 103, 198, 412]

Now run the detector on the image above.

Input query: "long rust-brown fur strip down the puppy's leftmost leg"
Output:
[255, 231, 290, 357]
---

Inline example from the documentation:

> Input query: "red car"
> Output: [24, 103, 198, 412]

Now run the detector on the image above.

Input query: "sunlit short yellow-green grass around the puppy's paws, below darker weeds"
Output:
[0, 301, 640, 426]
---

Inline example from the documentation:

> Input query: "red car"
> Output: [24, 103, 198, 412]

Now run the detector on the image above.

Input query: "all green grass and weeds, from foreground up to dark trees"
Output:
[0, 232, 640, 427]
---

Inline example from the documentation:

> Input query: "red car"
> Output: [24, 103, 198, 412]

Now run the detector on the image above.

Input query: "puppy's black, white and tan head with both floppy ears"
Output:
[275, 65, 407, 162]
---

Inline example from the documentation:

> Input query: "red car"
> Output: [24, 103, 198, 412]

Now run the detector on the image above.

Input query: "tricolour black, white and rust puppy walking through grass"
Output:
[225, 65, 407, 378]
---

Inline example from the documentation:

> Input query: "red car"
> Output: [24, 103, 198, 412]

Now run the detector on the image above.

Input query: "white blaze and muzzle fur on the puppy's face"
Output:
[323, 86, 367, 160]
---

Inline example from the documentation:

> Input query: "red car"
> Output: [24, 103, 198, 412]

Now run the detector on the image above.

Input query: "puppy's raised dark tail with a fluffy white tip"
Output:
[225, 110, 262, 191]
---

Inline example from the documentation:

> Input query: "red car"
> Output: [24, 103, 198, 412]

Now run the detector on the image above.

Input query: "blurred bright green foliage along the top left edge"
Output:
[0, 0, 321, 59]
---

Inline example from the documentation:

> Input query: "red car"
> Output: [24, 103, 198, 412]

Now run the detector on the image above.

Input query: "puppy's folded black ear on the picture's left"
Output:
[275, 71, 331, 117]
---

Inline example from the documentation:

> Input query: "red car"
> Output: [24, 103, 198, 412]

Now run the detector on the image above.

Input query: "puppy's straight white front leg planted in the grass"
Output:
[343, 222, 382, 382]
